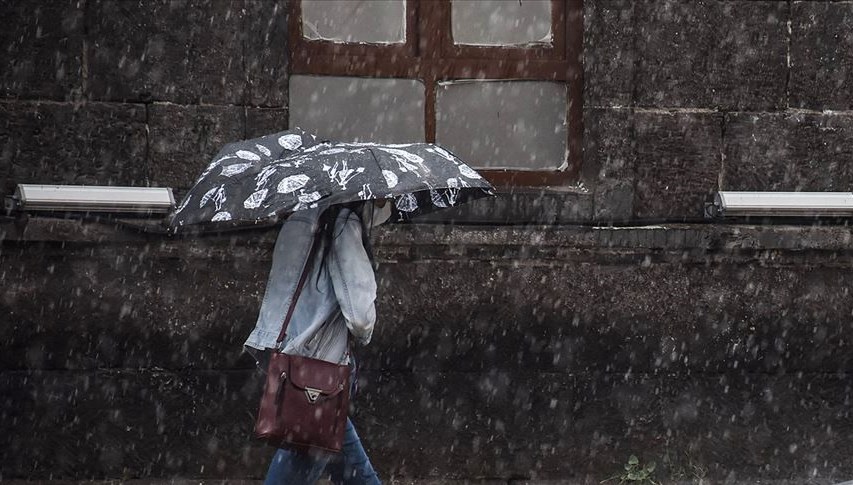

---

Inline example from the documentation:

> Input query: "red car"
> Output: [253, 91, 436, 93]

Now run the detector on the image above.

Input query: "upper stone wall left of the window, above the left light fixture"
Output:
[0, 0, 287, 194]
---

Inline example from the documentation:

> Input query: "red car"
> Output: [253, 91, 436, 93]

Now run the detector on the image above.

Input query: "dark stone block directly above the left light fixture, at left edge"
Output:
[0, 102, 147, 194]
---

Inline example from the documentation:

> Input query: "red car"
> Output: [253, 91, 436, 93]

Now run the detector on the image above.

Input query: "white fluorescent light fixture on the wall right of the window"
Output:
[705, 192, 853, 217]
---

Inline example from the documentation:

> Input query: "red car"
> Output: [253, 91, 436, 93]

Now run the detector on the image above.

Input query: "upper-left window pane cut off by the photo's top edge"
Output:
[302, 0, 406, 44]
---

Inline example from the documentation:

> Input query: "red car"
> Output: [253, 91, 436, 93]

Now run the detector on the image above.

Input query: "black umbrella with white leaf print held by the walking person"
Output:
[170, 129, 493, 231]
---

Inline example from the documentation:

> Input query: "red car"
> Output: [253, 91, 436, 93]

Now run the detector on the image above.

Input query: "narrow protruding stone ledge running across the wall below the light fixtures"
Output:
[0, 217, 853, 253]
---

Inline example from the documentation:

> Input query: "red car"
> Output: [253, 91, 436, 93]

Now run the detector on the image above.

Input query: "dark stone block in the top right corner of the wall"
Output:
[790, 2, 853, 110]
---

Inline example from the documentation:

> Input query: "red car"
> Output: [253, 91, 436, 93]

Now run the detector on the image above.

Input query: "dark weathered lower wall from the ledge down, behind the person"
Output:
[0, 221, 853, 483]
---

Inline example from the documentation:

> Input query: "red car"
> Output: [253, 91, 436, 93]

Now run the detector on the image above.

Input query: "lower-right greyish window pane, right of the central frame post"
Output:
[436, 81, 567, 170]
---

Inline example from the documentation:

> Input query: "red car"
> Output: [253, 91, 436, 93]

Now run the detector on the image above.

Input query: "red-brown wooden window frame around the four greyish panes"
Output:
[288, 0, 583, 187]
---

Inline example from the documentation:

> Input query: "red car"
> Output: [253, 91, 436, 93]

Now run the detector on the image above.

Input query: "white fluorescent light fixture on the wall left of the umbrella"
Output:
[12, 184, 175, 214]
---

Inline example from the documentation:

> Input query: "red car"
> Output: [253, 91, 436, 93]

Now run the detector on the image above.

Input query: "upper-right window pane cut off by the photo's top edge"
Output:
[450, 0, 552, 46]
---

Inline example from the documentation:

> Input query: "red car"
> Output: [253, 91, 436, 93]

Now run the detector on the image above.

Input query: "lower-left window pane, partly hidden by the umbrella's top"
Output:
[290, 75, 425, 143]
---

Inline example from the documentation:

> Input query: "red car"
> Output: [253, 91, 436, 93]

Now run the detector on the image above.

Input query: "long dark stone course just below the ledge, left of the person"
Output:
[0, 241, 270, 369]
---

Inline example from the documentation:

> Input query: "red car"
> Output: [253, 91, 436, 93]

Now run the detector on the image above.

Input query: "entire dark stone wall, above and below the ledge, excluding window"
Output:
[0, 0, 853, 483]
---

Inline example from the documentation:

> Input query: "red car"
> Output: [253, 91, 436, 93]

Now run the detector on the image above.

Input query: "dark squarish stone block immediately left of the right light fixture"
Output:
[634, 112, 722, 219]
